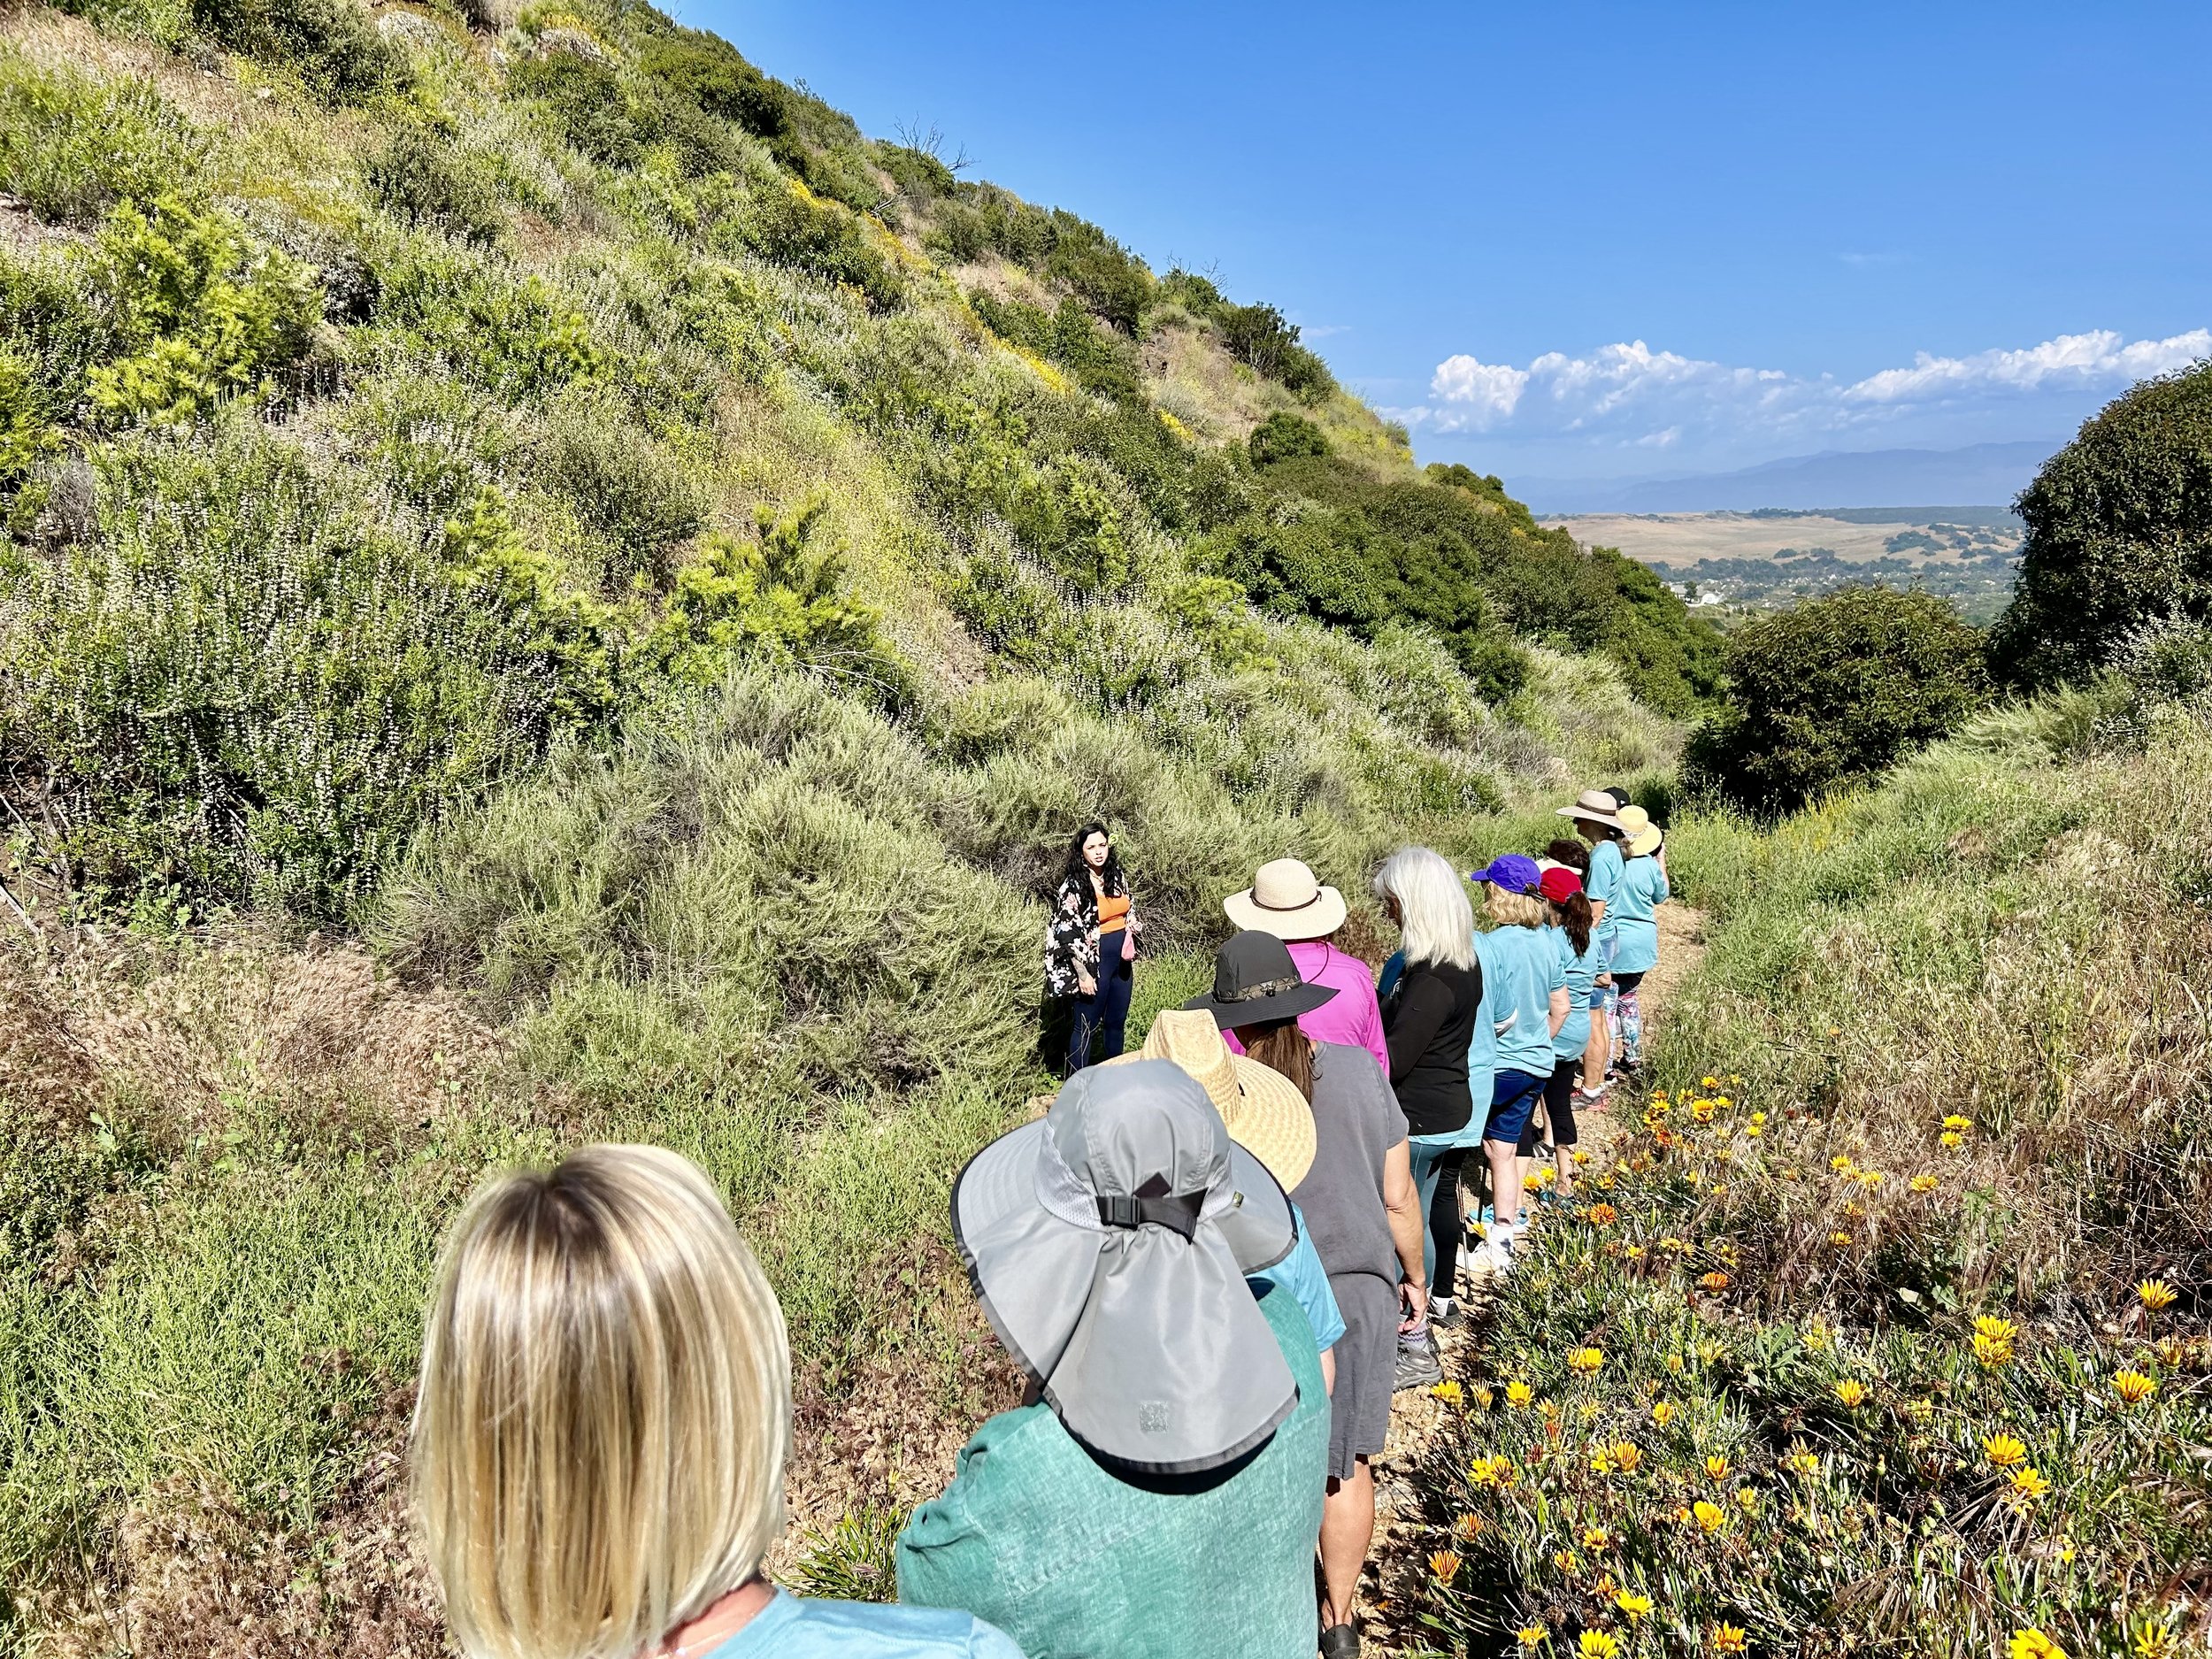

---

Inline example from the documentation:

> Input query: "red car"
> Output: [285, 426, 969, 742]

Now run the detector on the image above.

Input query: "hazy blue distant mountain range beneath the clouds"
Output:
[1507, 441, 2062, 513]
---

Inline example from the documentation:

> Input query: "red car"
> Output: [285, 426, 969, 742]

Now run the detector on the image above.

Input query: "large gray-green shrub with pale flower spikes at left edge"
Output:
[0, 429, 588, 914]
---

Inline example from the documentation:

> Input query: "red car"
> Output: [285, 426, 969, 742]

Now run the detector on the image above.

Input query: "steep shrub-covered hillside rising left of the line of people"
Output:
[0, 0, 1717, 1655]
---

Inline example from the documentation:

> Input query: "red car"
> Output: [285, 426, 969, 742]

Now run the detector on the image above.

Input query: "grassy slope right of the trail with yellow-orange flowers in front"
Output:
[1420, 724, 2212, 1659]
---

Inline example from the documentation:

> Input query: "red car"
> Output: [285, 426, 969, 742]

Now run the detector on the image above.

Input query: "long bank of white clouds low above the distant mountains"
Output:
[1392, 327, 2212, 449]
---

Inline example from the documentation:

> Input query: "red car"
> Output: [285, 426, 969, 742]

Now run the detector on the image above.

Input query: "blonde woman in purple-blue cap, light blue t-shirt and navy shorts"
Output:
[1471, 852, 1569, 1274]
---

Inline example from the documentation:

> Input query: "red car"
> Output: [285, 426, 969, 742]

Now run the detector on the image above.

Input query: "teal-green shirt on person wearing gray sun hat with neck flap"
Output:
[898, 1292, 1330, 1659]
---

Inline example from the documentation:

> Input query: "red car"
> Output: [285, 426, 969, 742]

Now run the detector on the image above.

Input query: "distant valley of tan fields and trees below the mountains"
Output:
[1544, 507, 2022, 624]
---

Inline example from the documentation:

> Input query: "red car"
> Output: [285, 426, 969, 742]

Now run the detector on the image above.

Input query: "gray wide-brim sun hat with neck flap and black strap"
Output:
[954, 1060, 1299, 1476]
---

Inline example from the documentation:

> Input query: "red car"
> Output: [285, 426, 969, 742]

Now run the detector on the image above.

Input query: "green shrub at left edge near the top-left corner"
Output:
[0, 56, 208, 224]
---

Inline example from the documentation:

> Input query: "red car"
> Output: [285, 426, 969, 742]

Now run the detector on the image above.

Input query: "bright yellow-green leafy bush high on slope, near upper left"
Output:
[87, 195, 323, 427]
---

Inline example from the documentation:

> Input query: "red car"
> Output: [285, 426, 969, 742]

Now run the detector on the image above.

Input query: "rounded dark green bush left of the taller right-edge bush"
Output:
[1686, 588, 1985, 812]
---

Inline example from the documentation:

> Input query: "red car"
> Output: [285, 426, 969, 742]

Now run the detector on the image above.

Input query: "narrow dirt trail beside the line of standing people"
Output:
[1361, 905, 1706, 1655]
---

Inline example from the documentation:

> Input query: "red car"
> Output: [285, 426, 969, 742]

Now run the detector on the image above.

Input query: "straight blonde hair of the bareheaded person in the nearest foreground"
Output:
[414, 1146, 792, 1659]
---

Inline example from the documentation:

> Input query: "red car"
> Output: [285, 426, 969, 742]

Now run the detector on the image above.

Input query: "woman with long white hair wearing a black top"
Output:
[1374, 848, 1482, 1354]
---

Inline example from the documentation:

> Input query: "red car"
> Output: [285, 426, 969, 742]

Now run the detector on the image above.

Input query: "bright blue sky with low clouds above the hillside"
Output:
[664, 0, 2212, 478]
